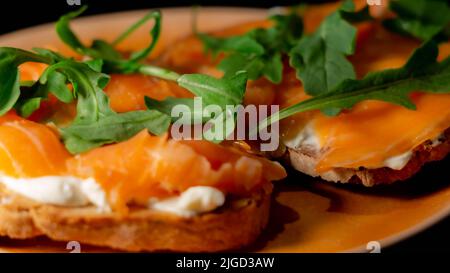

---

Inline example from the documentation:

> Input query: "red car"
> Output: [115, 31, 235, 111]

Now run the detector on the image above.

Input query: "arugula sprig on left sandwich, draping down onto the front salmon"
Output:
[0, 47, 170, 153]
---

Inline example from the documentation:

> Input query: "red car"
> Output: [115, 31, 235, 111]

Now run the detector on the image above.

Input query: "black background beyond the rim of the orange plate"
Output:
[0, 0, 450, 253]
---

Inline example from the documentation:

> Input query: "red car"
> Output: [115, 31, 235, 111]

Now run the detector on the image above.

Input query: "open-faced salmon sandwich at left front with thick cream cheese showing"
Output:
[0, 8, 286, 252]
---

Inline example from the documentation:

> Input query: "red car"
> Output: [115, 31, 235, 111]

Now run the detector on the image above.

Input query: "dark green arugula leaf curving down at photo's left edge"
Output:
[0, 47, 51, 115]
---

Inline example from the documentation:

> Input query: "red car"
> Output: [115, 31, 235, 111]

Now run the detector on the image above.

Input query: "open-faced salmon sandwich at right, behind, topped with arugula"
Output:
[163, 0, 450, 186]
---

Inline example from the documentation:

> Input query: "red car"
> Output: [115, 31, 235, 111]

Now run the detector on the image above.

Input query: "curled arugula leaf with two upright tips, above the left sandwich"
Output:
[56, 6, 161, 73]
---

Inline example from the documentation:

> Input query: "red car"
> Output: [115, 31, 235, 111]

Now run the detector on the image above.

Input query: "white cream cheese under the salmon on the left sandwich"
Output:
[0, 176, 225, 217]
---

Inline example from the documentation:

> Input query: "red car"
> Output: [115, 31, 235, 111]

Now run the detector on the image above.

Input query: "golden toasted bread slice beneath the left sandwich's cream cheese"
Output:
[0, 184, 271, 252]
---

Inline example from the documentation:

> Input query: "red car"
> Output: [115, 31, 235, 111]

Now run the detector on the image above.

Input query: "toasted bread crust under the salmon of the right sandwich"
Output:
[286, 129, 450, 187]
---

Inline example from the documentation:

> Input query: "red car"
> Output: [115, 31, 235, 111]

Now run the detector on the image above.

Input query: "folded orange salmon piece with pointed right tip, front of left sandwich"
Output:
[67, 131, 286, 210]
